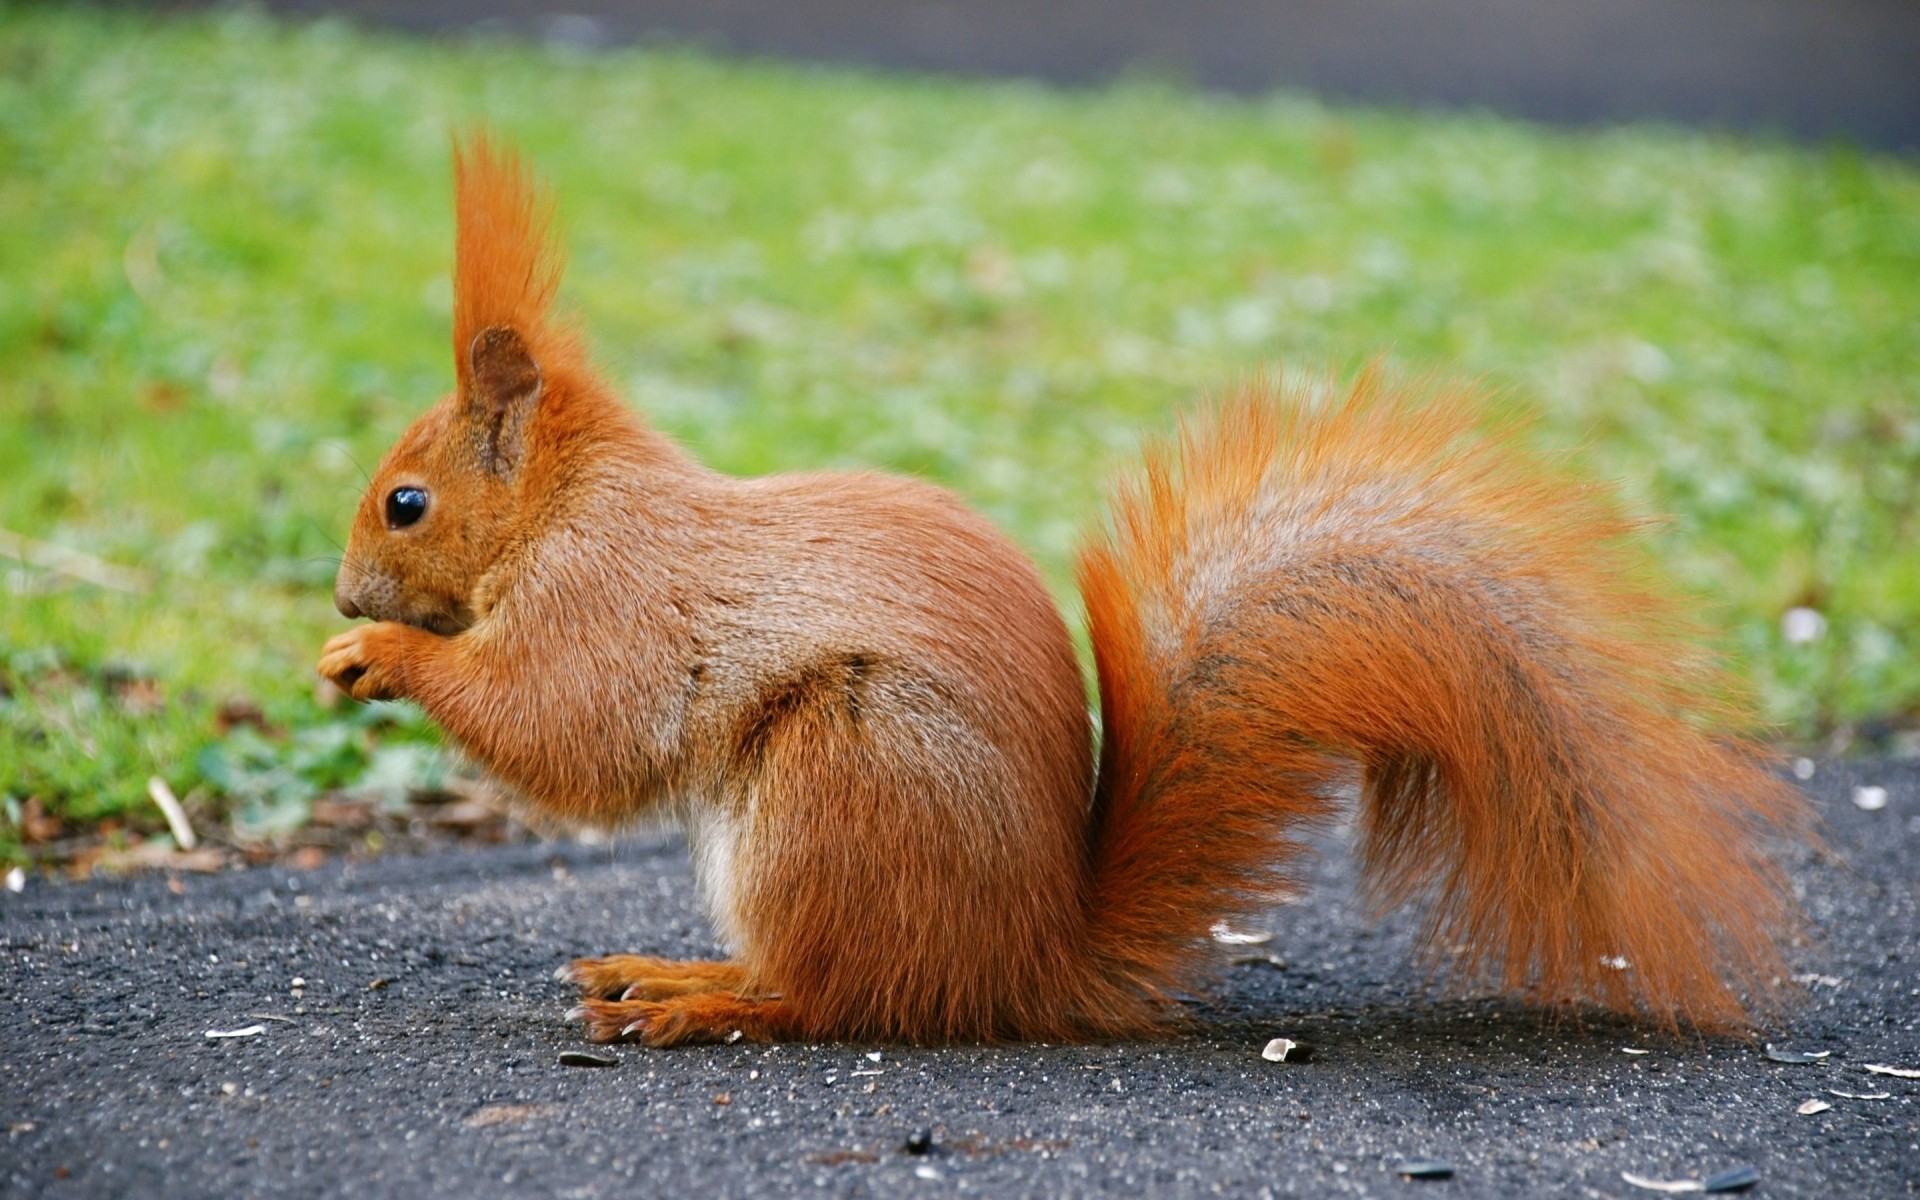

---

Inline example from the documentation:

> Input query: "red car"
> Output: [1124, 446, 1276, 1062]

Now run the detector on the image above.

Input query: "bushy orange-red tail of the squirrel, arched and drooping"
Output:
[1079, 376, 1803, 1029]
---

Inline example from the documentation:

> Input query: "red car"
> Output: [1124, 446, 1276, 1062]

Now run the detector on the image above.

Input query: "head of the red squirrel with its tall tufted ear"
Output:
[334, 132, 593, 634]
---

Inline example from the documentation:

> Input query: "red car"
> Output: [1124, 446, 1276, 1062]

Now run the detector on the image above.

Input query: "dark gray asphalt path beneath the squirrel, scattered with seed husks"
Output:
[0, 762, 1920, 1198]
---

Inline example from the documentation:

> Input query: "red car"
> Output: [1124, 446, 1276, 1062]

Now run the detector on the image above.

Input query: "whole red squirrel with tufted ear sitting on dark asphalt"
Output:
[319, 134, 1805, 1046]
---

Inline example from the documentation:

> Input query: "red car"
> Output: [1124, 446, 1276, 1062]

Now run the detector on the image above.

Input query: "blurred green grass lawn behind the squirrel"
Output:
[0, 8, 1920, 852]
